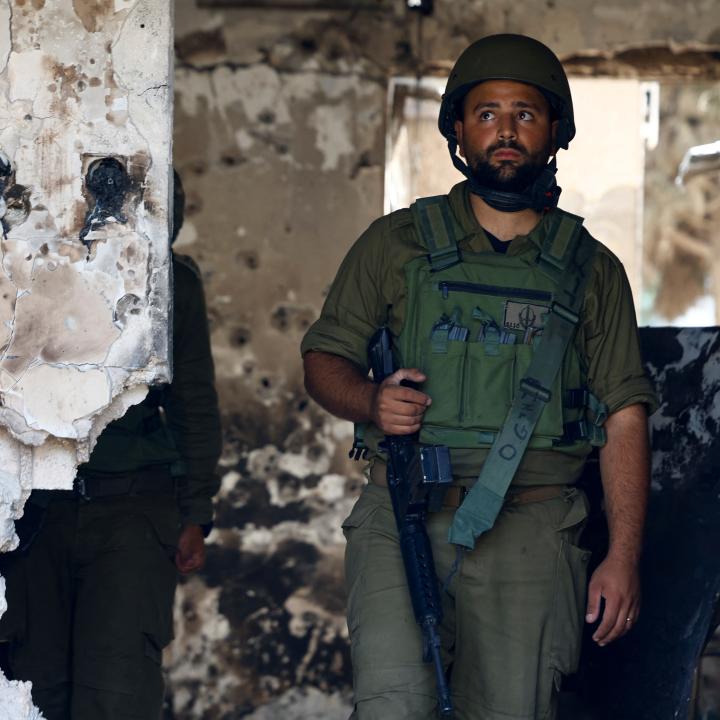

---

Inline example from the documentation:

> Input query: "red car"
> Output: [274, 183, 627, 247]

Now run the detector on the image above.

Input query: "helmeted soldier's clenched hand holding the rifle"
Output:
[370, 368, 432, 435]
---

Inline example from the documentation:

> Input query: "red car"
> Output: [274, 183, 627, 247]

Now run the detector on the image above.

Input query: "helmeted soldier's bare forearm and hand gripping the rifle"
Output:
[303, 351, 431, 435]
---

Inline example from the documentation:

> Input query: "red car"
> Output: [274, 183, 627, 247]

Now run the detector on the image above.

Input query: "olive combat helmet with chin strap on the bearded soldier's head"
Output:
[438, 34, 575, 212]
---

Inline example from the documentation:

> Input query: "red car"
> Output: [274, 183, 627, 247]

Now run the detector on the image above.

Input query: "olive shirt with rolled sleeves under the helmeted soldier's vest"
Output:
[302, 182, 657, 484]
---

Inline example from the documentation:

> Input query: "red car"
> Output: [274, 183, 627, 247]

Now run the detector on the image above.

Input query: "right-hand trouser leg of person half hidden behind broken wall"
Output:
[72, 497, 177, 720]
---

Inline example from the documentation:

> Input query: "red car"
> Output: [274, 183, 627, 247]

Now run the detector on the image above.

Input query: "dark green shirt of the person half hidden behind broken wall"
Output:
[79, 255, 222, 525]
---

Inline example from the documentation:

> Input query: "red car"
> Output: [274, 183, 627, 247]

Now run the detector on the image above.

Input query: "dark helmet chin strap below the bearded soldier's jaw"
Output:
[448, 137, 562, 212]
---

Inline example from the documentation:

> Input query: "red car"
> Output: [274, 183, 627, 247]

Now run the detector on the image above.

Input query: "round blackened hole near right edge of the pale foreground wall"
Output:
[80, 157, 132, 248]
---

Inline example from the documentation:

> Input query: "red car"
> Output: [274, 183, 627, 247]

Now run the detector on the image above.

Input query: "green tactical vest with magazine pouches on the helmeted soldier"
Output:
[356, 196, 607, 455]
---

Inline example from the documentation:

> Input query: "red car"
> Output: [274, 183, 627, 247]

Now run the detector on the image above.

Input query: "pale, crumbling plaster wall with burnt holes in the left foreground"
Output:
[0, 0, 172, 720]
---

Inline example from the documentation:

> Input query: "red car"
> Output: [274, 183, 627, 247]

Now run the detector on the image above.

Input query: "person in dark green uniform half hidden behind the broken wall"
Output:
[0, 175, 221, 720]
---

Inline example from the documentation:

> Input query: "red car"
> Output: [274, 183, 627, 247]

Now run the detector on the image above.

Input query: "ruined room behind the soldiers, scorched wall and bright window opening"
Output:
[0, 0, 720, 720]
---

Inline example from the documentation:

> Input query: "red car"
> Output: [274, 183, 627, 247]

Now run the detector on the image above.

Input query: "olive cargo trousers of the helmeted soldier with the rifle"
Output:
[343, 483, 590, 720]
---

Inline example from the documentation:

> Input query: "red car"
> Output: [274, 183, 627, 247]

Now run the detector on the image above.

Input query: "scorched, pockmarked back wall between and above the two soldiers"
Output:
[166, 0, 720, 720]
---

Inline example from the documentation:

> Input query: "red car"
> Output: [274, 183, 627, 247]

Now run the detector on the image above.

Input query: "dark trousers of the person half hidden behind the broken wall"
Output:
[0, 492, 179, 720]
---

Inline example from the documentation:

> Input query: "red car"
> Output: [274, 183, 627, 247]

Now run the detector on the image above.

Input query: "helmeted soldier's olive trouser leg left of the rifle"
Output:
[343, 485, 456, 720]
